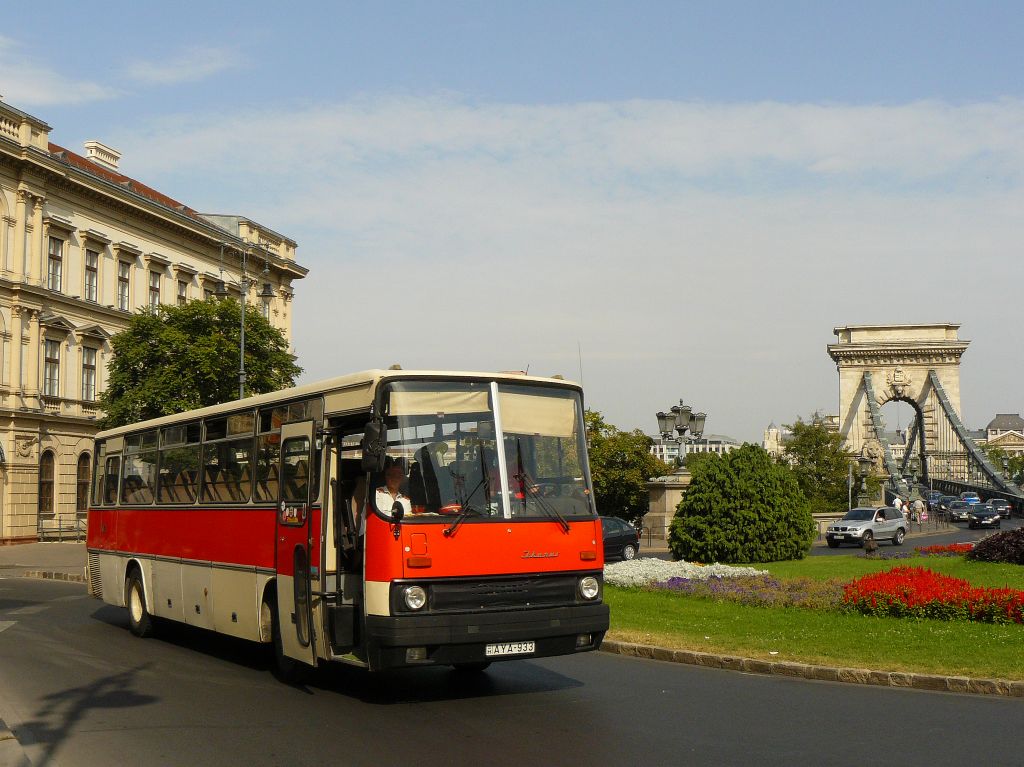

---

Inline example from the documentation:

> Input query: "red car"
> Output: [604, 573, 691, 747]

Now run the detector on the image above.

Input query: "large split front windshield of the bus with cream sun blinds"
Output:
[372, 381, 595, 523]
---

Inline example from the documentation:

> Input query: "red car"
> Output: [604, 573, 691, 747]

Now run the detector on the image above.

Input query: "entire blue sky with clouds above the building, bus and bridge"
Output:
[0, 2, 1024, 439]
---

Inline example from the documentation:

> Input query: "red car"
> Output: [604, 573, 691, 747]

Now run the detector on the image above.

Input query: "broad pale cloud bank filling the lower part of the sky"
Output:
[108, 97, 1024, 438]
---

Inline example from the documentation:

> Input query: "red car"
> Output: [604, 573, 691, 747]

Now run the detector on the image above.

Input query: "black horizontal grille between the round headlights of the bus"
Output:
[430, 576, 579, 611]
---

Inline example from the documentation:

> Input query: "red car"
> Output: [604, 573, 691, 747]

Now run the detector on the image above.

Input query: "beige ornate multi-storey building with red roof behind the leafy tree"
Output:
[0, 102, 306, 543]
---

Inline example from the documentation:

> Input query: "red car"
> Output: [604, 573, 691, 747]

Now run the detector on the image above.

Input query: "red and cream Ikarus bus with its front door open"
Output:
[88, 370, 608, 672]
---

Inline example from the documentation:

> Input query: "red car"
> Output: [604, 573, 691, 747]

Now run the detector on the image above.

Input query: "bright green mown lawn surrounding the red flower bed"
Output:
[605, 556, 1024, 679]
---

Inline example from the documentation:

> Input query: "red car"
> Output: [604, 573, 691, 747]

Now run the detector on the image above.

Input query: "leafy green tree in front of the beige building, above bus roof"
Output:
[99, 299, 302, 428]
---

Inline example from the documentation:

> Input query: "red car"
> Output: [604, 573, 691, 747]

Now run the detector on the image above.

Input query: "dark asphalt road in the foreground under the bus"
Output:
[0, 579, 1024, 767]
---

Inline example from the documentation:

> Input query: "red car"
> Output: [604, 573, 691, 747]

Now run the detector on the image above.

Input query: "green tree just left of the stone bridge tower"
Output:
[785, 414, 853, 513]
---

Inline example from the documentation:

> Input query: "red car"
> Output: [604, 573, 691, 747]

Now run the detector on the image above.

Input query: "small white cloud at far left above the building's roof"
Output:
[0, 36, 118, 106]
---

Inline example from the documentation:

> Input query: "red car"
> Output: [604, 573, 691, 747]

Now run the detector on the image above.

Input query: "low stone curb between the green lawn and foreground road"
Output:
[601, 639, 1024, 697]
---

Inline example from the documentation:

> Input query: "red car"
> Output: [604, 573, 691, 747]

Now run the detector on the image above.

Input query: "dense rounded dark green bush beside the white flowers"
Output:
[669, 444, 815, 563]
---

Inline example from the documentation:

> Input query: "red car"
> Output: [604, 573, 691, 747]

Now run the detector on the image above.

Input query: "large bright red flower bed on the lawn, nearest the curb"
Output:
[843, 566, 1024, 624]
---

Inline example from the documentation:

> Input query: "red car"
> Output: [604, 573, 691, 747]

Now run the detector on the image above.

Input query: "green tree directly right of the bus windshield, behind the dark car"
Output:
[584, 410, 672, 521]
